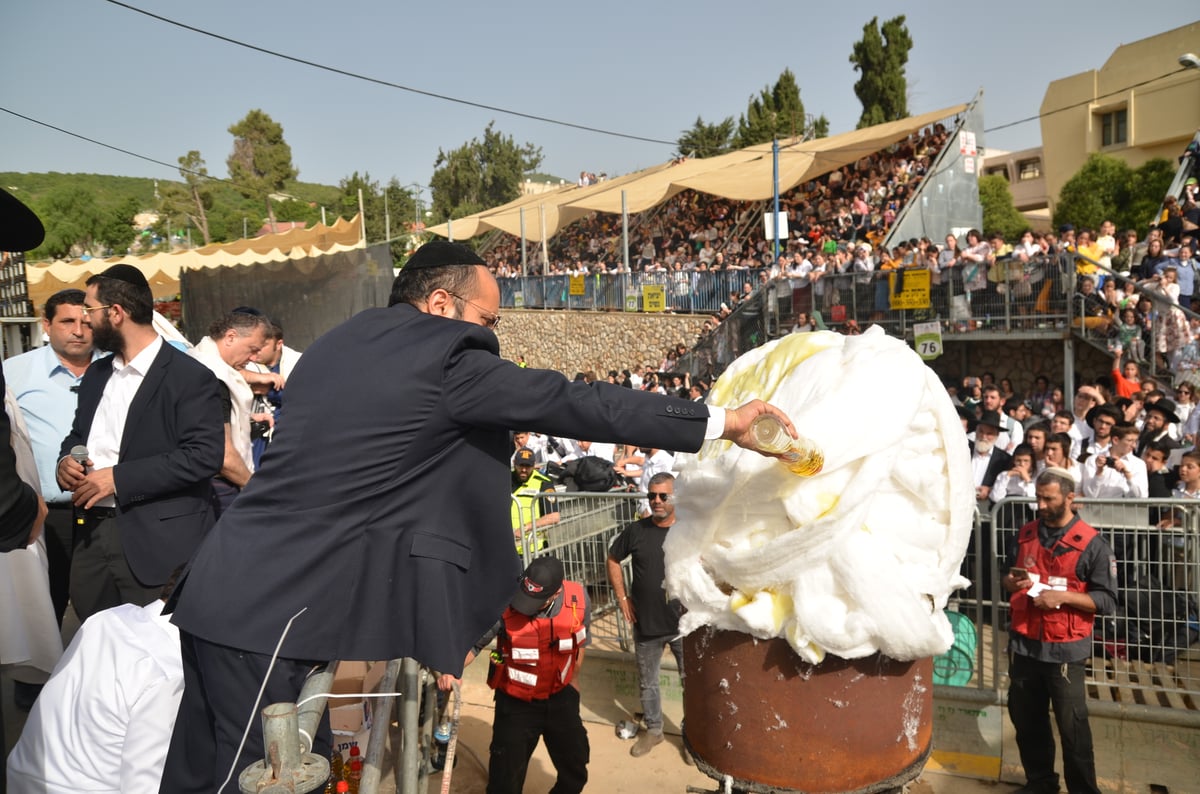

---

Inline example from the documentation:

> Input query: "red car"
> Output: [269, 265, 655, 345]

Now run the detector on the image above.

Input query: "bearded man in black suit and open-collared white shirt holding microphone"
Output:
[58, 265, 224, 620]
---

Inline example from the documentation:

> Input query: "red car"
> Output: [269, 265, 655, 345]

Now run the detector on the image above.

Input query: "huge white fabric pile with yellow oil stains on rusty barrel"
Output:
[665, 327, 974, 663]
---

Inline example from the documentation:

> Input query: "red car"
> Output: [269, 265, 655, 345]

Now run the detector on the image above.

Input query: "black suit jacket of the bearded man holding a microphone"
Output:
[60, 341, 224, 585]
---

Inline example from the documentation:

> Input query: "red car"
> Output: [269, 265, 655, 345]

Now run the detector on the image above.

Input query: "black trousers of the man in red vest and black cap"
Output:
[487, 686, 592, 794]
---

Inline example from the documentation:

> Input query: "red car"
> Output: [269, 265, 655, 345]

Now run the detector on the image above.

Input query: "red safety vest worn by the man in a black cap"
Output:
[487, 581, 588, 700]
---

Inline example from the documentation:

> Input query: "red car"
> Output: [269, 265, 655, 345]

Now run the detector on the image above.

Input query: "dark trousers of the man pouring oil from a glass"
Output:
[158, 631, 332, 794]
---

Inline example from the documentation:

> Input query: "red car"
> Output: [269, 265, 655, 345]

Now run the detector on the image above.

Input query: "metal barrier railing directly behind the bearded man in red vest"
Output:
[935, 498, 1200, 711]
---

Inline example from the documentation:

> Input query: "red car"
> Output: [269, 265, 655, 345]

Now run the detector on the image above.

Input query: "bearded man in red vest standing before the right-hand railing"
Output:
[1002, 468, 1117, 794]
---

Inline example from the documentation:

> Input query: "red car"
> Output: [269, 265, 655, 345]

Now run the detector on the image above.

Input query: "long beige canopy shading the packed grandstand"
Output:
[427, 104, 967, 241]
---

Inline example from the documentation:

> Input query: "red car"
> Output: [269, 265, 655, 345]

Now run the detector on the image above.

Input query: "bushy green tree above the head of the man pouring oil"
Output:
[430, 121, 542, 219]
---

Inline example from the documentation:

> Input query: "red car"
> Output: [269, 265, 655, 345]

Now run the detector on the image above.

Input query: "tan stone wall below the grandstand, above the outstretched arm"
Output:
[497, 309, 707, 378]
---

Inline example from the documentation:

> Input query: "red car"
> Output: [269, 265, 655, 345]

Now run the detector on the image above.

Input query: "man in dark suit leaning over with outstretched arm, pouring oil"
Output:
[162, 241, 791, 794]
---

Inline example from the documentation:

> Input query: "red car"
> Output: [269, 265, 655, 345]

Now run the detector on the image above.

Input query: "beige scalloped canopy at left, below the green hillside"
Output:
[25, 216, 364, 307]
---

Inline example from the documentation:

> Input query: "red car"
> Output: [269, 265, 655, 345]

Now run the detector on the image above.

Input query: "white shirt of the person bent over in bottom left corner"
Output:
[8, 601, 184, 794]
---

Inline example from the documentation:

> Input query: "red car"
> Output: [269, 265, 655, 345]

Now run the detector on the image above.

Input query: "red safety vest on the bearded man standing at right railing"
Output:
[1008, 521, 1099, 643]
